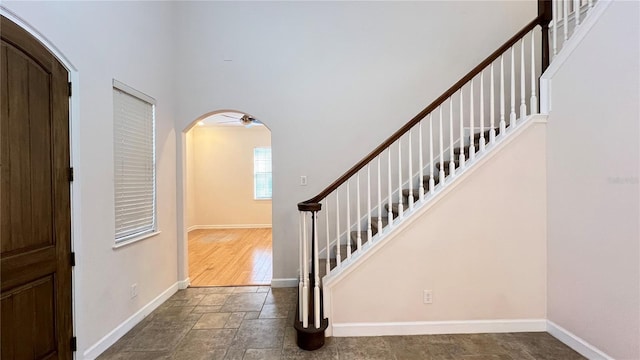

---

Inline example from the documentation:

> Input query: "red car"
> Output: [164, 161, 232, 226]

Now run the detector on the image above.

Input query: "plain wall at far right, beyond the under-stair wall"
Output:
[547, 1, 640, 360]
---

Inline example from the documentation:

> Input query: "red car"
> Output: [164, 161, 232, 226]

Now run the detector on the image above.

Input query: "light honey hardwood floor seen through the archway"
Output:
[189, 229, 272, 286]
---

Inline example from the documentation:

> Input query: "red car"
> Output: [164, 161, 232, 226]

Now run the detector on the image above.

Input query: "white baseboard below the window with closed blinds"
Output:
[82, 279, 180, 359]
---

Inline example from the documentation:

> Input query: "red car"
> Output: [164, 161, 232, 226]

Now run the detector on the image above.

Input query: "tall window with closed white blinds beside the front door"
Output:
[113, 80, 157, 243]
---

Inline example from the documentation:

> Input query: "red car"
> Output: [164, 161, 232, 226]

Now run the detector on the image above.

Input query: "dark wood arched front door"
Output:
[0, 17, 73, 360]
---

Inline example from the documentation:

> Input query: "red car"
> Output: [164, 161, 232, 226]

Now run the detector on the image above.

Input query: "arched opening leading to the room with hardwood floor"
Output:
[185, 110, 273, 286]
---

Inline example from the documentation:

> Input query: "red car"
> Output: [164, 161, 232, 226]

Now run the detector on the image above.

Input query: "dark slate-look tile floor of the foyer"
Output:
[98, 286, 583, 360]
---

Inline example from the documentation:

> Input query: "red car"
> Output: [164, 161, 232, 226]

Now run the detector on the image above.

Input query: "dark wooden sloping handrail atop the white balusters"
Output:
[298, 14, 549, 211]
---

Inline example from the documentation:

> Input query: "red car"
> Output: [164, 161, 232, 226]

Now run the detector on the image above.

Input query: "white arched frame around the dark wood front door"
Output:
[0, 5, 83, 348]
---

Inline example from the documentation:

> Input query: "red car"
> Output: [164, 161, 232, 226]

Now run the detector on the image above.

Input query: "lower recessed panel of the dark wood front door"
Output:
[0, 275, 56, 359]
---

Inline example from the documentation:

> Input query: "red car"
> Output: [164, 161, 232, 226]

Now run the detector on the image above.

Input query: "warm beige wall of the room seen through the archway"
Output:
[187, 126, 271, 227]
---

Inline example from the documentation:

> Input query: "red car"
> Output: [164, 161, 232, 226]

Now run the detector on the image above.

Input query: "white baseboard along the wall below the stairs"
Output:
[332, 319, 547, 337]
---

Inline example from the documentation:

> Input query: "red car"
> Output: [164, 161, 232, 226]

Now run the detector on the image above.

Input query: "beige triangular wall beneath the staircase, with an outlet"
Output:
[328, 124, 546, 325]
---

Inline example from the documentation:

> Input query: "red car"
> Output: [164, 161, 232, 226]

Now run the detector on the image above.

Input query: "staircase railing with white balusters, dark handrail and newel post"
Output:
[294, 0, 593, 350]
